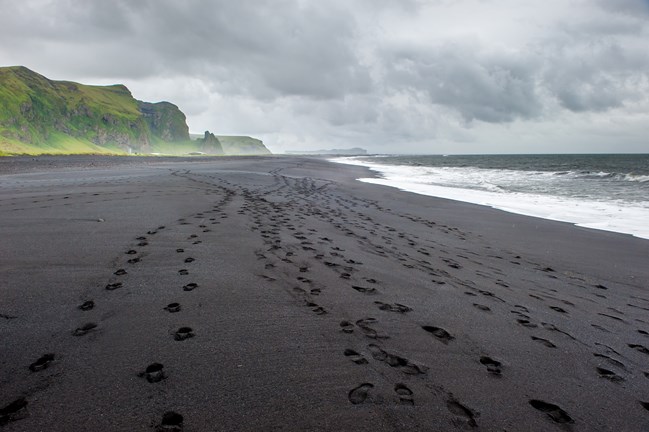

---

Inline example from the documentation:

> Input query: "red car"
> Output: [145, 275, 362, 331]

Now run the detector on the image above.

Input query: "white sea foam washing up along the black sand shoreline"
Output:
[332, 158, 649, 239]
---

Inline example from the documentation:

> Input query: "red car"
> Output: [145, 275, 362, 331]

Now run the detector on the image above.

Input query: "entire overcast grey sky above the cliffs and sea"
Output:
[0, 0, 649, 153]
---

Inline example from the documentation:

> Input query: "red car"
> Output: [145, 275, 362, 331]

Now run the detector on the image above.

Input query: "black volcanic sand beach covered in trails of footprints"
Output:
[0, 157, 649, 431]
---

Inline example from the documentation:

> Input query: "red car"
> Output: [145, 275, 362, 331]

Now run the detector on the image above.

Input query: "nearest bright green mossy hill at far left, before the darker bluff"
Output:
[0, 66, 149, 148]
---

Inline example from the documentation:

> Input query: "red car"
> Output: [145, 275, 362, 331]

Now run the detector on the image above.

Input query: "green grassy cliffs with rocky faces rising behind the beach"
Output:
[0, 66, 270, 155]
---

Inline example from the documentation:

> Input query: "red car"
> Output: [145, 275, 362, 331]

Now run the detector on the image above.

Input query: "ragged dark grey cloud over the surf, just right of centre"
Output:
[386, 44, 542, 123]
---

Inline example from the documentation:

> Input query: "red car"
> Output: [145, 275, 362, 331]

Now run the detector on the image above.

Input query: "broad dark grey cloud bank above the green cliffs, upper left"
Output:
[3, 0, 369, 99]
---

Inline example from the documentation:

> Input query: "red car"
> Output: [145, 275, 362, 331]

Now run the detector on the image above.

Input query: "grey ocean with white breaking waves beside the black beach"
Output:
[332, 154, 649, 239]
